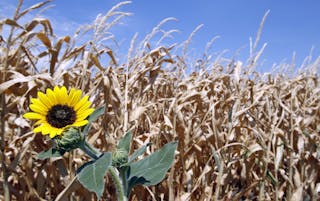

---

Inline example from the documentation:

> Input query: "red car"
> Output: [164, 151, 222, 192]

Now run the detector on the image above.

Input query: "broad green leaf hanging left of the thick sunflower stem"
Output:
[78, 152, 112, 198]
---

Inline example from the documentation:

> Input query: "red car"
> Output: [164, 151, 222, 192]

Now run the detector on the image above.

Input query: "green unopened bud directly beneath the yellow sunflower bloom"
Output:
[54, 127, 84, 152]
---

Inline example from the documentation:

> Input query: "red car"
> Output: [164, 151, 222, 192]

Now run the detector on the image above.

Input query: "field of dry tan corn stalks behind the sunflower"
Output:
[0, 1, 320, 201]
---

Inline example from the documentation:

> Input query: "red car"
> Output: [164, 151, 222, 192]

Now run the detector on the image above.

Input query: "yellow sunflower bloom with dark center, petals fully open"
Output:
[23, 86, 94, 138]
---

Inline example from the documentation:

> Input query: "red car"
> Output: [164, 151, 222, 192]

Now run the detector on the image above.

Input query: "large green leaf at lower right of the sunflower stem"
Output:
[128, 142, 178, 192]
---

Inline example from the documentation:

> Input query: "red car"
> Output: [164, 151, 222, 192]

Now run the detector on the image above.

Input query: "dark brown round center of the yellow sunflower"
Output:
[46, 105, 76, 128]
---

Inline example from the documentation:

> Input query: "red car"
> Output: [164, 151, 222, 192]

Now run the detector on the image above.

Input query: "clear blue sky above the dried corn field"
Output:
[0, 0, 320, 71]
